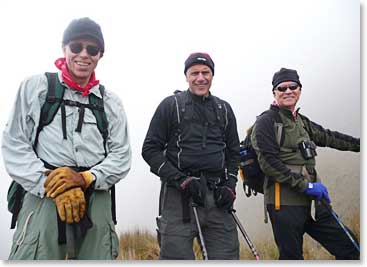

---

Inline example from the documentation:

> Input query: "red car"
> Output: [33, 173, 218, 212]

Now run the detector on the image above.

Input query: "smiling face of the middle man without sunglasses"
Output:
[186, 65, 213, 96]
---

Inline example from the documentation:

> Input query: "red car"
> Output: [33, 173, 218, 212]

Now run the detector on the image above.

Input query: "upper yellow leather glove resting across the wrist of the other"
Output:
[44, 167, 93, 198]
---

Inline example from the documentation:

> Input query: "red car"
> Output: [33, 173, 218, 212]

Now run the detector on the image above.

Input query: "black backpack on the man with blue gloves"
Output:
[239, 109, 284, 197]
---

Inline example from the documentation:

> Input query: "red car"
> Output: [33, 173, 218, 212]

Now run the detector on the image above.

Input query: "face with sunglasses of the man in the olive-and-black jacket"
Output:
[273, 81, 301, 112]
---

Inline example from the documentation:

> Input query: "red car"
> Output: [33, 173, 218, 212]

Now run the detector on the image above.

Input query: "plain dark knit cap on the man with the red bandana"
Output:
[62, 18, 104, 53]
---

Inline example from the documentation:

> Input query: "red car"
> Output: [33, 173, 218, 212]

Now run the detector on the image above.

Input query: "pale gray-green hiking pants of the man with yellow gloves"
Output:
[9, 191, 119, 260]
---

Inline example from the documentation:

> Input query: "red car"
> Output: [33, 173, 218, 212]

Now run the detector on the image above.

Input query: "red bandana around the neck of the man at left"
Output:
[55, 57, 99, 96]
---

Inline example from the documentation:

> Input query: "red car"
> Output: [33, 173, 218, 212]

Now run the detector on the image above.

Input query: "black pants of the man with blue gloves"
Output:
[267, 205, 359, 260]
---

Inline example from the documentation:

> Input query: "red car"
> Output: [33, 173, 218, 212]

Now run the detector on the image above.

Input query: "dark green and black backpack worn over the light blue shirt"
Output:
[7, 72, 116, 229]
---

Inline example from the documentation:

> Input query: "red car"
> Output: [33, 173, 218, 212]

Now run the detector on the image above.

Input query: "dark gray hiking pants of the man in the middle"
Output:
[157, 185, 239, 260]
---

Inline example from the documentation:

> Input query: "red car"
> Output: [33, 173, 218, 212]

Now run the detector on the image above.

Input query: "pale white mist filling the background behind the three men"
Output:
[0, 0, 362, 259]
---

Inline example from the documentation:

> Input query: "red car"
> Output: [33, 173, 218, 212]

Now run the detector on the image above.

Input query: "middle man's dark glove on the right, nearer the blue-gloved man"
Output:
[214, 178, 236, 210]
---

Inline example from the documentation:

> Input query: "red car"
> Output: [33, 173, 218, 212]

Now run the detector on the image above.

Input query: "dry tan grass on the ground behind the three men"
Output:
[118, 211, 360, 260]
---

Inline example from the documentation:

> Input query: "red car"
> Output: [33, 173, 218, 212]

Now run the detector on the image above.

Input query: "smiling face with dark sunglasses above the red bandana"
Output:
[63, 39, 101, 86]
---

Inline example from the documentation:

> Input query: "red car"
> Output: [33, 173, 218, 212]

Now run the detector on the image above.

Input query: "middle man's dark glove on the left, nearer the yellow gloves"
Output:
[176, 176, 205, 206]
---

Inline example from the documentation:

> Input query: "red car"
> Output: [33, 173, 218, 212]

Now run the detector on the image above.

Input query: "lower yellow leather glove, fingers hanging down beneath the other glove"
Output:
[54, 187, 86, 223]
